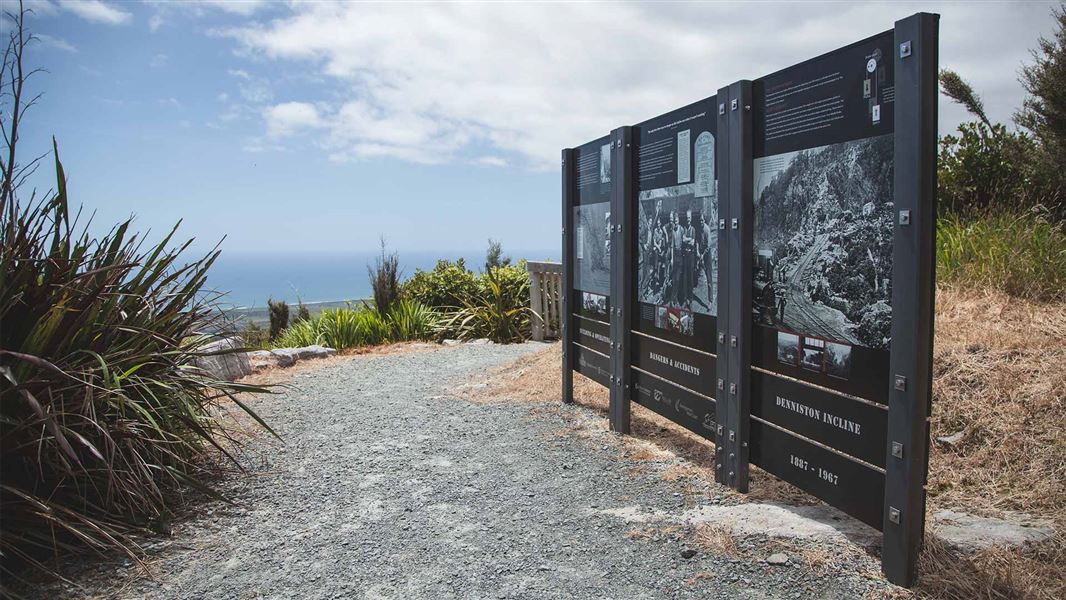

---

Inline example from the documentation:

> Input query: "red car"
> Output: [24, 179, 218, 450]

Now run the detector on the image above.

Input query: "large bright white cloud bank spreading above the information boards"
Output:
[224, 3, 1051, 167]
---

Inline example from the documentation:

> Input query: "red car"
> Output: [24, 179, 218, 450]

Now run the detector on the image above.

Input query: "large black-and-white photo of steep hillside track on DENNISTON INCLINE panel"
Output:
[753, 135, 893, 349]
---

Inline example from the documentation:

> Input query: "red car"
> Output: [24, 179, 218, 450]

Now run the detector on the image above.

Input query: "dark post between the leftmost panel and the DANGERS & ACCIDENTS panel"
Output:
[610, 126, 636, 434]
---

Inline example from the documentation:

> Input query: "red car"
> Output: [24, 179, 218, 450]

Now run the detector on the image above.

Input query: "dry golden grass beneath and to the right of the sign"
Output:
[465, 288, 1066, 600]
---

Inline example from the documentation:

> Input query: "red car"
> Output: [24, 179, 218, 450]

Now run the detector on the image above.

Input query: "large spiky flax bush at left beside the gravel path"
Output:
[0, 143, 275, 575]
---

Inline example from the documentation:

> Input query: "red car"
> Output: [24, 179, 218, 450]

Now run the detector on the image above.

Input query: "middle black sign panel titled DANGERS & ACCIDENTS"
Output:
[627, 97, 717, 437]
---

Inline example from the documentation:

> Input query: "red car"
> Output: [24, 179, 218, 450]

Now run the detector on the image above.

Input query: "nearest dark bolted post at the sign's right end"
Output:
[882, 13, 939, 586]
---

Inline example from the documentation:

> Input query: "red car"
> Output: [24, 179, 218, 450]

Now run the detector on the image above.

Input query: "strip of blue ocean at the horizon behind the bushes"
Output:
[208, 248, 560, 308]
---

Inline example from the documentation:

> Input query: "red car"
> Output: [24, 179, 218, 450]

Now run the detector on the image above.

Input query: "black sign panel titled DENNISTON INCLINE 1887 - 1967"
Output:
[750, 31, 895, 529]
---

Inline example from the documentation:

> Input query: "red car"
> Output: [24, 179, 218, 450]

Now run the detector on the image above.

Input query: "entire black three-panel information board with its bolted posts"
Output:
[562, 13, 939, 585]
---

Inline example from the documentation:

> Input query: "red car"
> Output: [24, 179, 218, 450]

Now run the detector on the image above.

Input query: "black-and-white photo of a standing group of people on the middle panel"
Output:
[636, 183, 718, 317]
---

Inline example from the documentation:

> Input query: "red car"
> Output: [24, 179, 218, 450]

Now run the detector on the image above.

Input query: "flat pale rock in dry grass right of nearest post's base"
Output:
[933, 510, 1055, 550]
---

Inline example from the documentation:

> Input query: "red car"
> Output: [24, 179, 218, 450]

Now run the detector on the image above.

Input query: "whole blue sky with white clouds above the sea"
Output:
[4, 1, 1053, 253]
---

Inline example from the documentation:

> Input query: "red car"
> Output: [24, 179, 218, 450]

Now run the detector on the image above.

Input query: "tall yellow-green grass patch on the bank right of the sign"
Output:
[936, 209, 1066, 301]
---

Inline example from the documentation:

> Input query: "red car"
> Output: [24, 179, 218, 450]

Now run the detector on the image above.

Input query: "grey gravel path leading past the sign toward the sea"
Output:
[31, 344, 884, 599]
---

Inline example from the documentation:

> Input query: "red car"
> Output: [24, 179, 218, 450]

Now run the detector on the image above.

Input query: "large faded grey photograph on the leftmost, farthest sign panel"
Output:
[574, 202, 611, 295]
